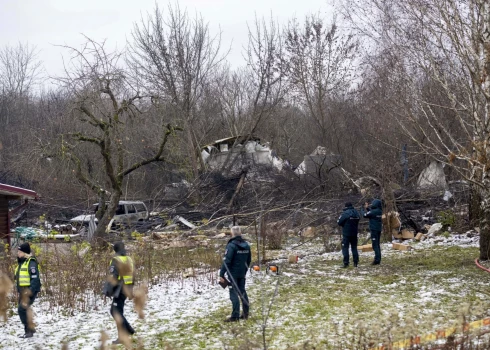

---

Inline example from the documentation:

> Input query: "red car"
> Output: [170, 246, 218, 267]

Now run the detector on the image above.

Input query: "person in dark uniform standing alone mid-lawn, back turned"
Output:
[219, 226, 252, 322]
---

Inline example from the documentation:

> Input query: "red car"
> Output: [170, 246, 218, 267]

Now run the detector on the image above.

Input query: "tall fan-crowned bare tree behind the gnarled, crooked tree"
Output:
[129, 5, 225, 177]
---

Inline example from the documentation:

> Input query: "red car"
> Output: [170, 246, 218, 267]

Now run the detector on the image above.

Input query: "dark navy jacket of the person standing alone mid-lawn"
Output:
[219, 236, 252, 278]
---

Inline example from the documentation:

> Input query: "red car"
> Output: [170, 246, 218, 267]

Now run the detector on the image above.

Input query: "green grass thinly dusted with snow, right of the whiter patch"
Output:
[153, 246, 490, 349]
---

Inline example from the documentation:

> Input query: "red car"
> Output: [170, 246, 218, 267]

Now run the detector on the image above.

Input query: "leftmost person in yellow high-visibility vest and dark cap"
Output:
[15, 242, 41, 338]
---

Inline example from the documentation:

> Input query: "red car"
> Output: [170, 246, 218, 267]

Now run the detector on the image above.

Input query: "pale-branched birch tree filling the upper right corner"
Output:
[345, 0, 490, 260]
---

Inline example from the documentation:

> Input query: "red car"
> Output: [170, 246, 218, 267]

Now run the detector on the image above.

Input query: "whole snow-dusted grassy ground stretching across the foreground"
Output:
[0, 235, 490, 350]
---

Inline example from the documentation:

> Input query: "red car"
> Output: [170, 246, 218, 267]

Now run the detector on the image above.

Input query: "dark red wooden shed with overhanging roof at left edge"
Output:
[0, 183, 37, 244]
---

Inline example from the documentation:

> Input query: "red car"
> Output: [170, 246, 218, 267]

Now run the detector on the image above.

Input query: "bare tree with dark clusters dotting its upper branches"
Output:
[284, 15, 357, 152]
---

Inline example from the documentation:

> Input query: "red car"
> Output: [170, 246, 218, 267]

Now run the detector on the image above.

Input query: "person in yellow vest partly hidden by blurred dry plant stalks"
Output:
[104, 242, 135, 344]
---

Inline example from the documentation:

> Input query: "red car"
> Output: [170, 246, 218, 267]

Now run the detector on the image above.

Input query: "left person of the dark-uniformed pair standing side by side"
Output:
[337, 202, 360, 268]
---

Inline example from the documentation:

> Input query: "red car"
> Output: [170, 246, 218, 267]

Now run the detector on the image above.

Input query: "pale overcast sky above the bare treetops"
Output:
[0, 0, 332, 76]
